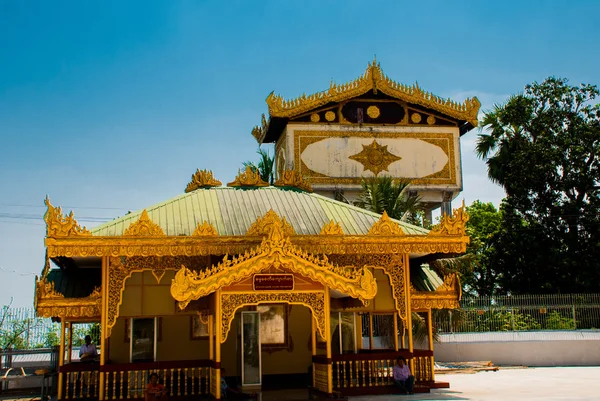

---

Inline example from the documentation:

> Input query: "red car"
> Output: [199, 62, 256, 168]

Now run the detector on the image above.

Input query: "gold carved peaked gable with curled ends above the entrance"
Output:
[171, 223, 377, 309]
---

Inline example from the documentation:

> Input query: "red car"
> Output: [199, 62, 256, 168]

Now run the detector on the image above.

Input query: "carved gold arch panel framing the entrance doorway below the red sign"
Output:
[221, 291, 326, 343]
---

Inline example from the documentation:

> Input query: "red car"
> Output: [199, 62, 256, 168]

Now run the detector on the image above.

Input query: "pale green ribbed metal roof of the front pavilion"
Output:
[90, 187, 429, 236]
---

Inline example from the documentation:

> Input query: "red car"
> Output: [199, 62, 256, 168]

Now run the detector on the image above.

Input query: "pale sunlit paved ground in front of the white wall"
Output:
[350, 367, 600, 401]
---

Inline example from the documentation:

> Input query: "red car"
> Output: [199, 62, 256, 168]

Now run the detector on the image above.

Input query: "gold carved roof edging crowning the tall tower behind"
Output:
[267, 60, 481, 126]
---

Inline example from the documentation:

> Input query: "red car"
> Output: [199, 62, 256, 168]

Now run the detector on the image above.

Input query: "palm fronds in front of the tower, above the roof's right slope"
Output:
[354, 176, 421, 221]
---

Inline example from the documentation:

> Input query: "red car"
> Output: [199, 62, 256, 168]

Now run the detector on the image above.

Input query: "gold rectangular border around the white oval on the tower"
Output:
[293, 130, 457, 186]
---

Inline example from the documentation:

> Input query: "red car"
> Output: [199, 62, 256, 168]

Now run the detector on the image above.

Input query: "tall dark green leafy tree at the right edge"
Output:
[476, 78, 600, 293]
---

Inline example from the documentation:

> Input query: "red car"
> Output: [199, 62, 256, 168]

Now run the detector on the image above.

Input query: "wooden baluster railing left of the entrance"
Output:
[60, 360, 211, 400]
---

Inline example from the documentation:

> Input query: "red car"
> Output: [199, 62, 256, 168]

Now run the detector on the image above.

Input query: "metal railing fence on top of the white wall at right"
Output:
[433, 294, 600, 333]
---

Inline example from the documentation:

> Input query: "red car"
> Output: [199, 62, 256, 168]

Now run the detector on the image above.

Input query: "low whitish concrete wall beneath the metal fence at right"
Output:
[434, 331, 600, 366]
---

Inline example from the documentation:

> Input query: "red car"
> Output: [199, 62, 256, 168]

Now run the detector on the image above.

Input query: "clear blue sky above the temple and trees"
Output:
[0, 0, 600, 306]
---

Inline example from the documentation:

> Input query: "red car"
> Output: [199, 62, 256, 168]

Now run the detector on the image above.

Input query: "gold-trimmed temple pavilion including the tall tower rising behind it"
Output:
[35, 62, 479, 400]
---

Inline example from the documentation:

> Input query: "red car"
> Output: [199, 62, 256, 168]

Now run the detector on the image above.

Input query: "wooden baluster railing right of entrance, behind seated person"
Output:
[332, 350, 433, 390]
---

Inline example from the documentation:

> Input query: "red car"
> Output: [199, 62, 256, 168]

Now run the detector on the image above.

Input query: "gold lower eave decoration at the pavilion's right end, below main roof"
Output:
[410, 273, 462, 311]
